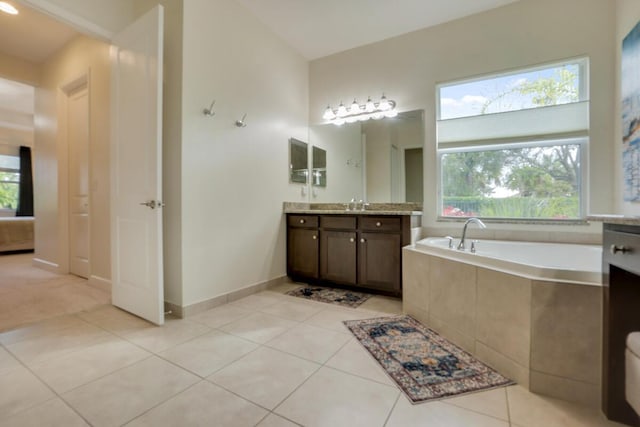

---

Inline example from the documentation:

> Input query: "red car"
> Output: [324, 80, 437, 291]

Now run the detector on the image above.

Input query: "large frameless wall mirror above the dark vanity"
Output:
[309, 110, 424, 203]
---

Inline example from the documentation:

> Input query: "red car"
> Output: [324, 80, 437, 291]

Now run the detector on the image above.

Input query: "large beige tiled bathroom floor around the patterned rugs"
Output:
[0, 284, 628, 427]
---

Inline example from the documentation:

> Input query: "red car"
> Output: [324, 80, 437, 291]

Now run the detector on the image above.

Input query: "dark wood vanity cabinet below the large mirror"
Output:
[287, 214, 411, 295]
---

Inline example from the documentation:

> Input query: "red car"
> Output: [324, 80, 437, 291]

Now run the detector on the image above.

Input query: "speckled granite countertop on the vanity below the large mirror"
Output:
[283, 202, 422, 215]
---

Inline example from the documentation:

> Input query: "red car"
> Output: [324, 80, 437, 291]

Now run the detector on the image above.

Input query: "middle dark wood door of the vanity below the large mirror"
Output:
[320, 230, 357, 285]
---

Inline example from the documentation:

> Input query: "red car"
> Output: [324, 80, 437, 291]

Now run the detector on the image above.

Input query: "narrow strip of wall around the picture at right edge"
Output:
[613, 0, 640, 215]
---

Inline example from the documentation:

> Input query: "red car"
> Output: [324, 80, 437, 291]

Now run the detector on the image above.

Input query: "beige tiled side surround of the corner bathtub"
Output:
[403, 241, 602, 407]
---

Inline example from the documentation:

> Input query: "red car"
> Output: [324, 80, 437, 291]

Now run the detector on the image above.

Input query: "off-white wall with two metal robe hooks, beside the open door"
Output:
[182, 0, 309, 306]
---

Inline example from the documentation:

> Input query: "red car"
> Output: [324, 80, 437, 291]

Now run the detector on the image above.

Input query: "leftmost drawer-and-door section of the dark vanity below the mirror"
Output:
[287, 215, 320, 279]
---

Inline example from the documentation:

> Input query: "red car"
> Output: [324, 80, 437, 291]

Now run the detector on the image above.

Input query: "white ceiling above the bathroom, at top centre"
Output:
[237, 0, 519, 60]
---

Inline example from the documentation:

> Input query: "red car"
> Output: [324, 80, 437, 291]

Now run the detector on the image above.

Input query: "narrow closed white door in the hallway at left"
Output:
[67, 84, 89, 278]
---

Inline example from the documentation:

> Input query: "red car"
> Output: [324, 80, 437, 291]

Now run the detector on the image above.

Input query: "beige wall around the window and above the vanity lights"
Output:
[309, 0, 615, 239]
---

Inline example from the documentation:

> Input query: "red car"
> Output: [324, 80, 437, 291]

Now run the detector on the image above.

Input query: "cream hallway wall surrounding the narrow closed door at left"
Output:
[33, 36, 111, 281]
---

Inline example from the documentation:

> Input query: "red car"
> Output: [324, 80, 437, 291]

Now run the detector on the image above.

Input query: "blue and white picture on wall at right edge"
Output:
[621, 22, 640, 202]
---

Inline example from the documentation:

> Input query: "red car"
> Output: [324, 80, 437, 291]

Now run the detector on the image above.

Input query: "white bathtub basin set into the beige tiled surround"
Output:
[415, 237, 602, 286]
